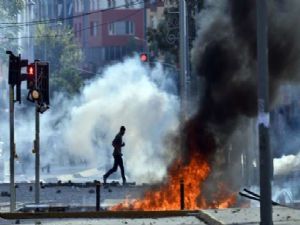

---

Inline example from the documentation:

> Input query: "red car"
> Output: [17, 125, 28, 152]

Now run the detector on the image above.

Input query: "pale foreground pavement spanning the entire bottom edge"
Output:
[0, 207, 300, 225]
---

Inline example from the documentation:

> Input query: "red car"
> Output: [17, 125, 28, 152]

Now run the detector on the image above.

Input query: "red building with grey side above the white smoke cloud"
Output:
[73, 1, 146, 71]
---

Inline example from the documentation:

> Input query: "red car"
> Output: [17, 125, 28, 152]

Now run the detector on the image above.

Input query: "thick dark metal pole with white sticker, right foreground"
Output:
[256, 0, 273, 225]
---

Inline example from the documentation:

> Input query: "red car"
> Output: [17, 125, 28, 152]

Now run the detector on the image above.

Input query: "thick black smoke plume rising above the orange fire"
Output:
[184, 0, 300, 192]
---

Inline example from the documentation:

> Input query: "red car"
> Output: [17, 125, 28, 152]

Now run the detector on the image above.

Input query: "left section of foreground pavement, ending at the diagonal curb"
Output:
[0, 210, 206, 225]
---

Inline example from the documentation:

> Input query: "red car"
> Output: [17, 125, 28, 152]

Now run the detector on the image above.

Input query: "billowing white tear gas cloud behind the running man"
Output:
[1, 57, 179, 182]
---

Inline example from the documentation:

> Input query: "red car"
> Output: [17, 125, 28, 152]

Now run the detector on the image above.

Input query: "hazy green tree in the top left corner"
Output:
[0, 0, 24, 61]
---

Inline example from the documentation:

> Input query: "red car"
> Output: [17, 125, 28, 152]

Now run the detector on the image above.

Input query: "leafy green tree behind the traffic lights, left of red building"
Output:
[34, 25, 83, 96]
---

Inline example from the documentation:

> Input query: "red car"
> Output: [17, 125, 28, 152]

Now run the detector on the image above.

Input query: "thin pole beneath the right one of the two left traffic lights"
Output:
[34, 102, 40, 204]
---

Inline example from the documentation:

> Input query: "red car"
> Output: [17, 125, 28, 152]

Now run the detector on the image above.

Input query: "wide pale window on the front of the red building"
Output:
[108, 21, 134, 35]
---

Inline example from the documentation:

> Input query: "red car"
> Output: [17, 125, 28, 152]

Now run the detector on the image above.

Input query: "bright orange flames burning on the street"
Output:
[110, 153, 236, 210]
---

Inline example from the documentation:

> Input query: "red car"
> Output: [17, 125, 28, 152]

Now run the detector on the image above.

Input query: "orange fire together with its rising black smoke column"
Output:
[113, 0, 300, 210]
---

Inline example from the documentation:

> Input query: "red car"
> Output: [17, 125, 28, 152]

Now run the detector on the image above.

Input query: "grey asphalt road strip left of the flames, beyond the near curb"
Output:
[0, 182, 149, 212]
